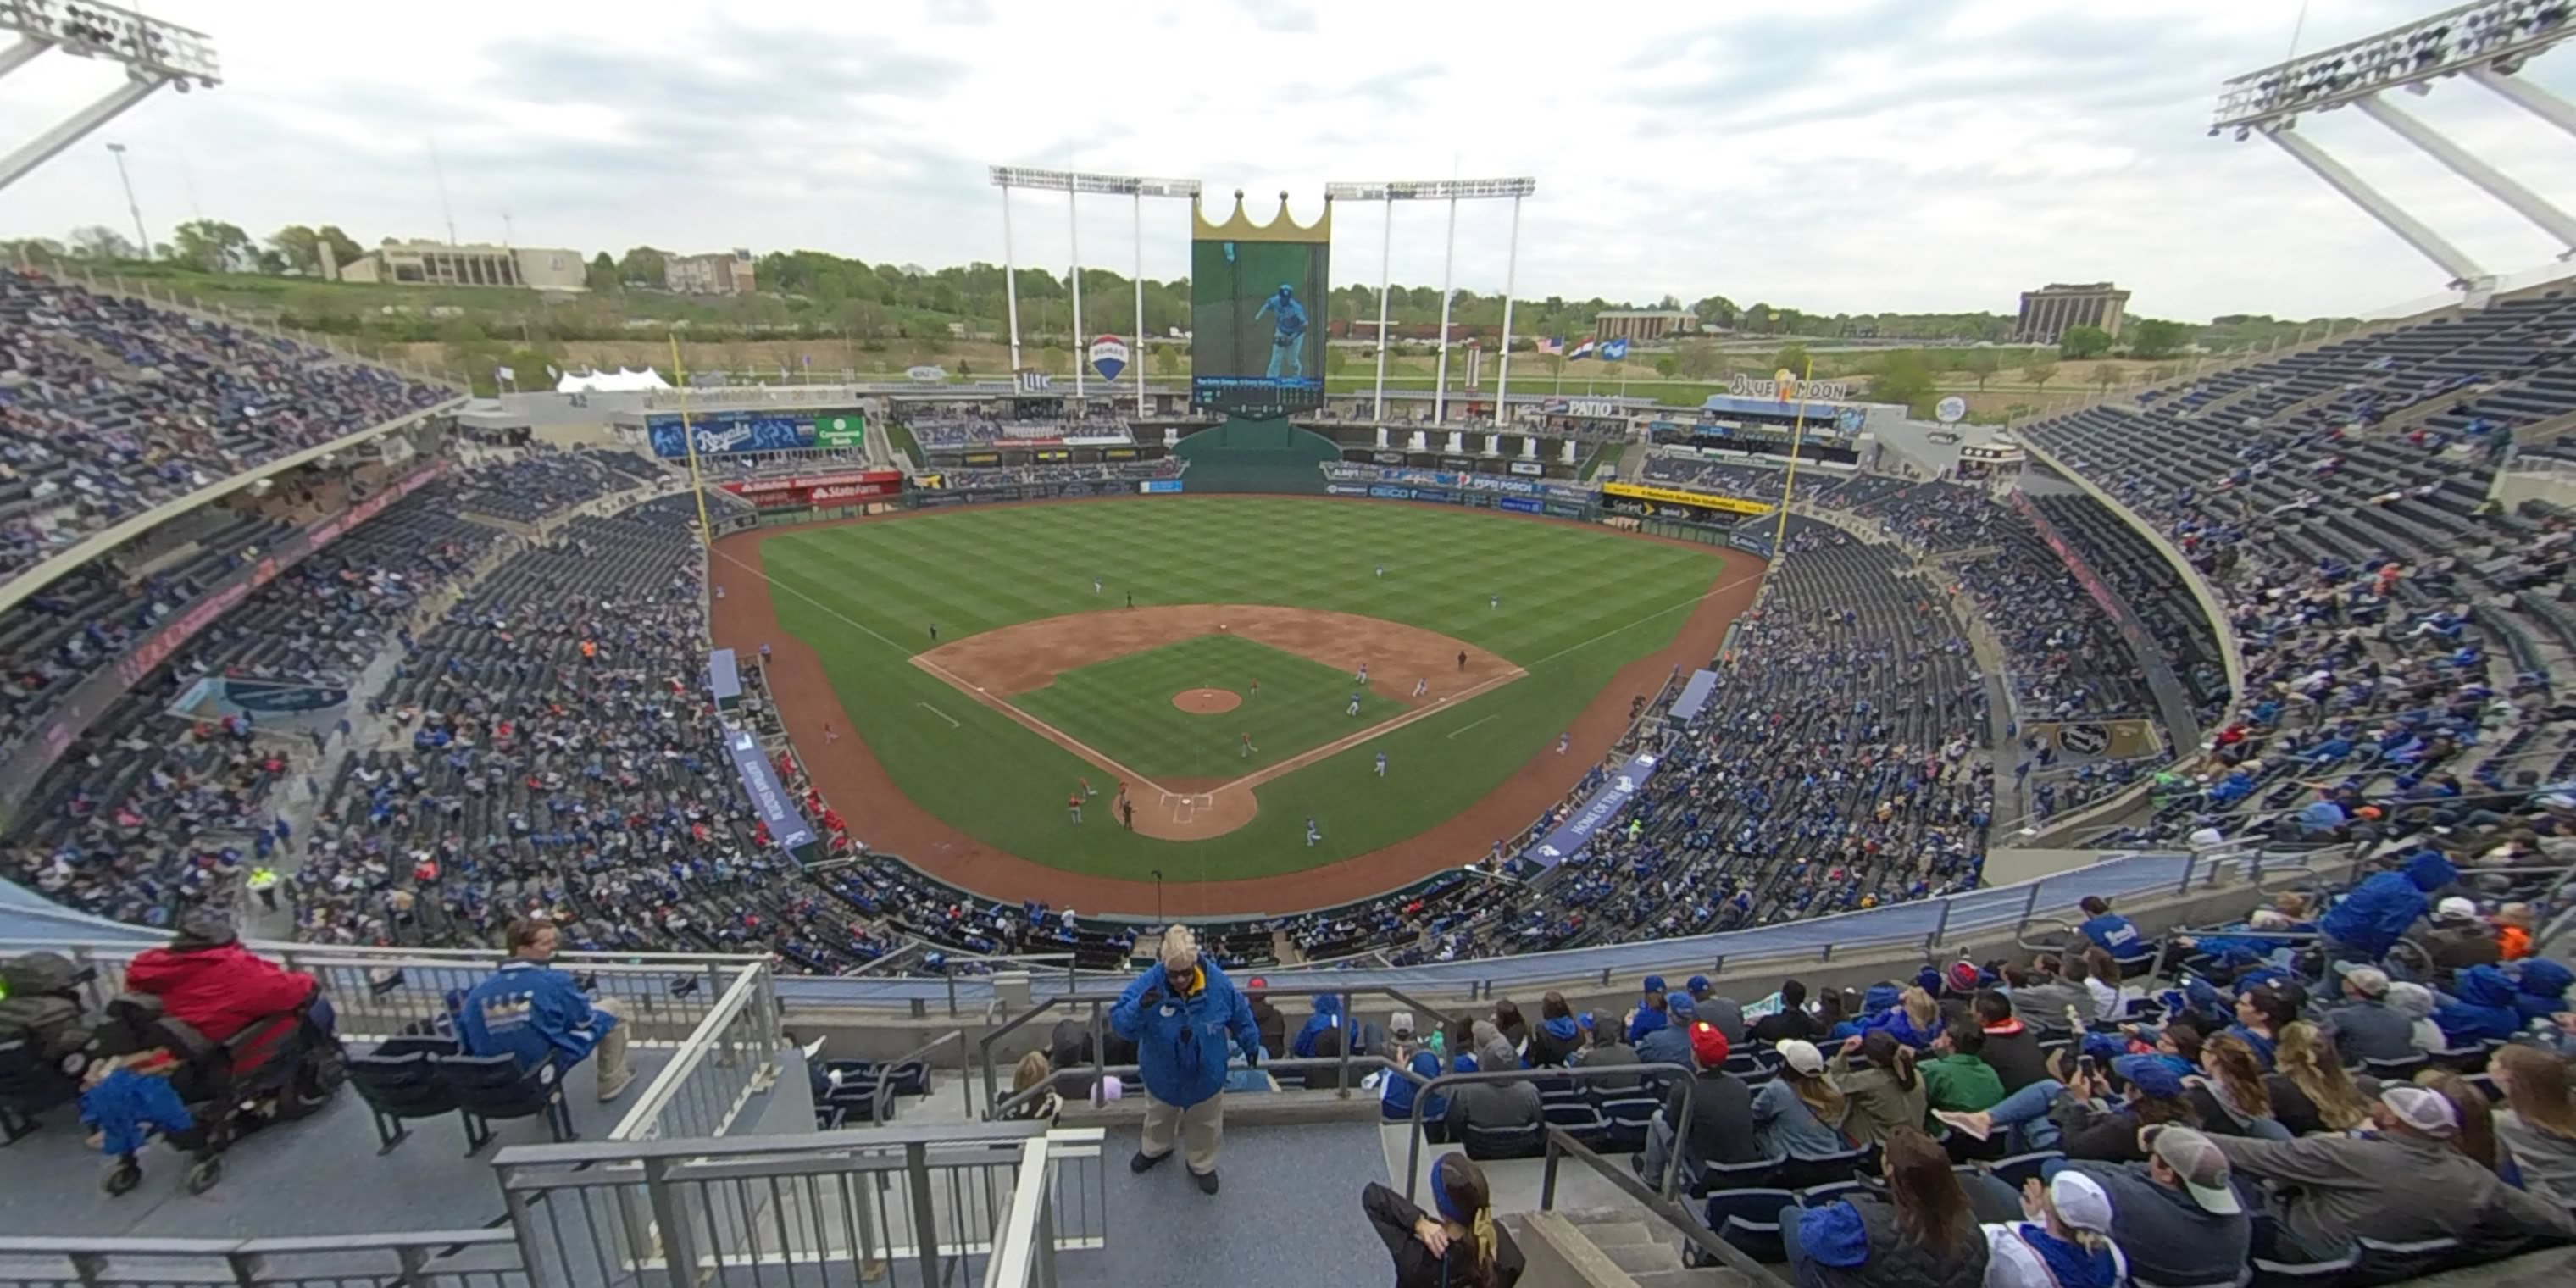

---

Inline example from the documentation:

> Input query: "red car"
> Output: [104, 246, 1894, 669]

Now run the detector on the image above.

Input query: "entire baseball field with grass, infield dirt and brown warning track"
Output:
[713, 497, 1759, 912]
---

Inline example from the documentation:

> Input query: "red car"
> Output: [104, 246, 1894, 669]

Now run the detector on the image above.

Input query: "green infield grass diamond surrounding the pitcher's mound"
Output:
[1013, 636, 1404, 783]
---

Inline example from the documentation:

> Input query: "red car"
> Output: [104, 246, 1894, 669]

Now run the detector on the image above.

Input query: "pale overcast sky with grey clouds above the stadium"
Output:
[0, 0, 2576, 319]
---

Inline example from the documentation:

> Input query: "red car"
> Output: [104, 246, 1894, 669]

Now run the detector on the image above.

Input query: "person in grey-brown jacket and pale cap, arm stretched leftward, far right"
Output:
[2210, 1085, 2576, 1249]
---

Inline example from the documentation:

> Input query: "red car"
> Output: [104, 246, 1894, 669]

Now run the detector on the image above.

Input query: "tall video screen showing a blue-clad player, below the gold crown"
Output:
[1190, 240, 1330, 420]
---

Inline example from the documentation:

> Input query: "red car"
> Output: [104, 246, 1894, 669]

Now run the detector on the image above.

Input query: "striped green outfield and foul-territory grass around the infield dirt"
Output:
[763, 497, 1724, 881]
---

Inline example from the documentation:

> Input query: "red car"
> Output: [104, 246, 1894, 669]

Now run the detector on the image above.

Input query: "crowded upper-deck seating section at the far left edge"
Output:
[0, 268, 453, 585]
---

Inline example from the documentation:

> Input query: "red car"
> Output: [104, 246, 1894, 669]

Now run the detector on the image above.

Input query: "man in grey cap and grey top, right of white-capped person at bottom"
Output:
[2040, 1123, 2254, 1283]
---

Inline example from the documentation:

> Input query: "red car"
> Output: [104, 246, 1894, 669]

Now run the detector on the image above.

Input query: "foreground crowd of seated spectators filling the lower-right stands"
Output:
[1308, 845, 2576, 1288]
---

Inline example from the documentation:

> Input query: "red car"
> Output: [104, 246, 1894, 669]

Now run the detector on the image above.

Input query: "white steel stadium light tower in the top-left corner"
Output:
[0, 0, 224, 193]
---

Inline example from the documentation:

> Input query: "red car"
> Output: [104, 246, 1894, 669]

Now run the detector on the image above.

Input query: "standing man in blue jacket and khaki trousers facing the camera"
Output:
[1110, 924, 1263, 1196]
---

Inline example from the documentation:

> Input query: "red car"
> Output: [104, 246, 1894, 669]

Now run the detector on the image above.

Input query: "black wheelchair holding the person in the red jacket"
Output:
[90, 991, 347, 1196]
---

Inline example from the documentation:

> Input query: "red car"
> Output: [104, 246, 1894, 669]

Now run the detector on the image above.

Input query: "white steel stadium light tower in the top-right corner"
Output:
[2210, 0, 2576, 296]
